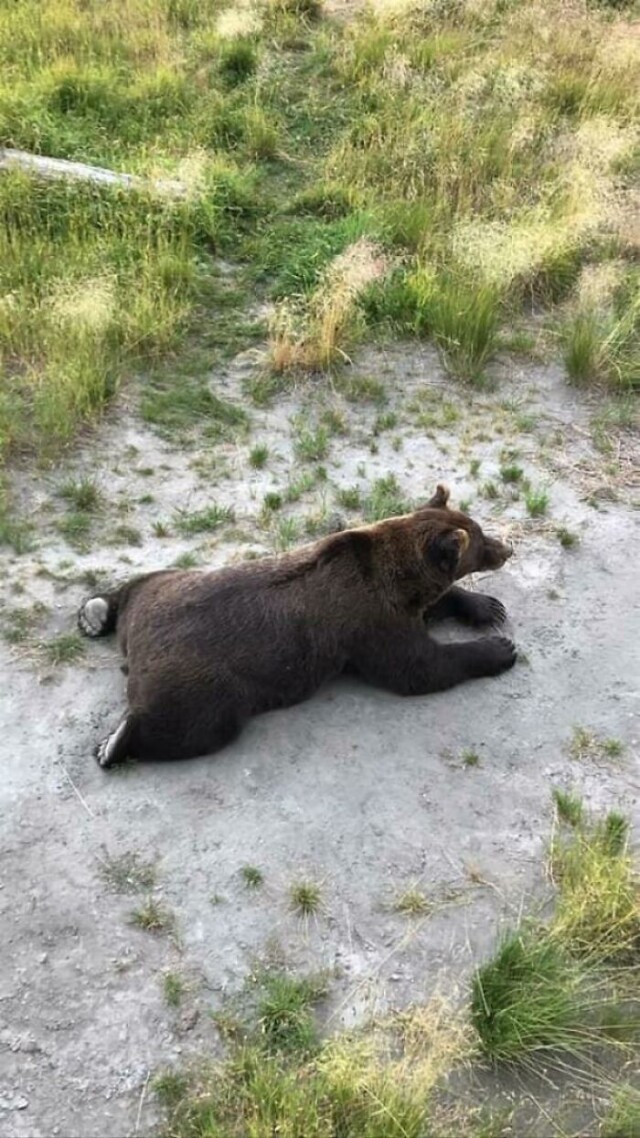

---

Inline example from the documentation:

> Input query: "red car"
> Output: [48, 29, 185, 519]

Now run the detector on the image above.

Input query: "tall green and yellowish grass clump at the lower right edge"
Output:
[471, 792, 640, 1064]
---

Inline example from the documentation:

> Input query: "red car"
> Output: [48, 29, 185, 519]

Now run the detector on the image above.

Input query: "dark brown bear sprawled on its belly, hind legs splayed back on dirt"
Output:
[79, 486, 516, 767]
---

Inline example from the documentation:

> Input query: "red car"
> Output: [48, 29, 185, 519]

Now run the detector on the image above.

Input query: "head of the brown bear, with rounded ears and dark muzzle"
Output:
[417, 486, 514, 582]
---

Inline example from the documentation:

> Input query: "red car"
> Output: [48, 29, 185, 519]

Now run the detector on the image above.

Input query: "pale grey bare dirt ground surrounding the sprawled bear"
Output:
[0, 346, 640, 1138]
